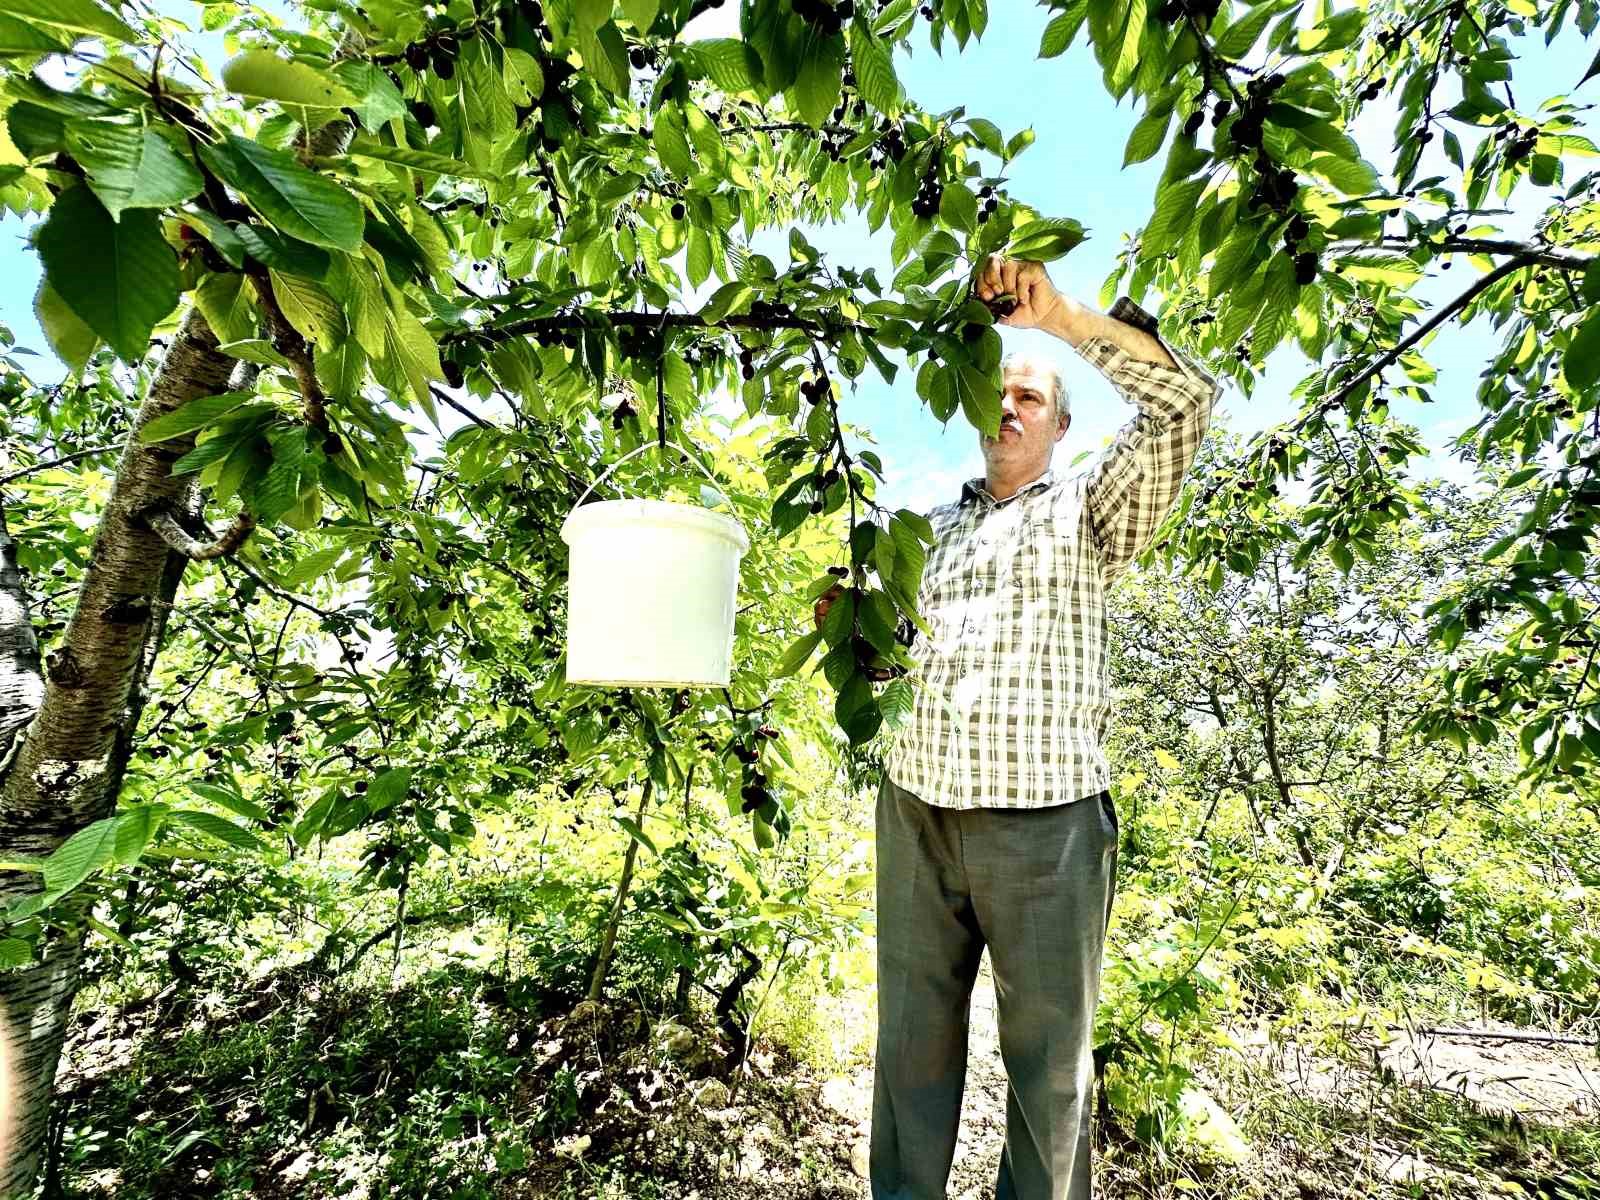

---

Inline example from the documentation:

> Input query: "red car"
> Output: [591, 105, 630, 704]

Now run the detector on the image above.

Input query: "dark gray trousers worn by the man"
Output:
[870, 774, 1117, 1200]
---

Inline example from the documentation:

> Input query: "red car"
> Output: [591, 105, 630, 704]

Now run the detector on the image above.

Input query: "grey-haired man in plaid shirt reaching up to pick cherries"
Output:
[818, 258, 1219, 1200]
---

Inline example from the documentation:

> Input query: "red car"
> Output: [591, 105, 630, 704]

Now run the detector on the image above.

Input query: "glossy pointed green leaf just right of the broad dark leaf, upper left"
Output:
[200, 133, 365, 251]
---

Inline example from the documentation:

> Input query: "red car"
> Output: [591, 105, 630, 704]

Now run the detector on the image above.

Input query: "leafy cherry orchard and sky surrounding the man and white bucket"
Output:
[0, 0, 1600, 1197]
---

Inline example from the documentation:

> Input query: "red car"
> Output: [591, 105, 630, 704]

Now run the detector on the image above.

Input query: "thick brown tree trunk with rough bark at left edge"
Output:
[0, 312, 234, 1200]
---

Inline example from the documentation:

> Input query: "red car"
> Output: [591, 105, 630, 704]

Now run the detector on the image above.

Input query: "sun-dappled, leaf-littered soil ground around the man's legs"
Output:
[59, 963, 1600, 1200]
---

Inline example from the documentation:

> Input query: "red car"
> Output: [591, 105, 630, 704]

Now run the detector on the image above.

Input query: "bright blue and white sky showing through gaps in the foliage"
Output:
[0, 0, 1600, 510]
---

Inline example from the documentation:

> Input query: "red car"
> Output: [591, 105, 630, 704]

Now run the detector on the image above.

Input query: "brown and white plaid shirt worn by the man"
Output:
[885, 296, 1221, 808]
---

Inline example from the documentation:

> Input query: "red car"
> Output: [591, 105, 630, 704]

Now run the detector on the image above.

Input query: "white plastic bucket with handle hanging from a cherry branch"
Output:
[562, 443, 750, 688]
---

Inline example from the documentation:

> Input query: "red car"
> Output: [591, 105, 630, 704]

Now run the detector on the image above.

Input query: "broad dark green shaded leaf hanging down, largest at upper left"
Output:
[35, 187, 179, 363]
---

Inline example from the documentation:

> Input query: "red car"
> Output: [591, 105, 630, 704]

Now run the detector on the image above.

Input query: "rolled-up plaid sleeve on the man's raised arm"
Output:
[1077, 301, 1222, 581]
